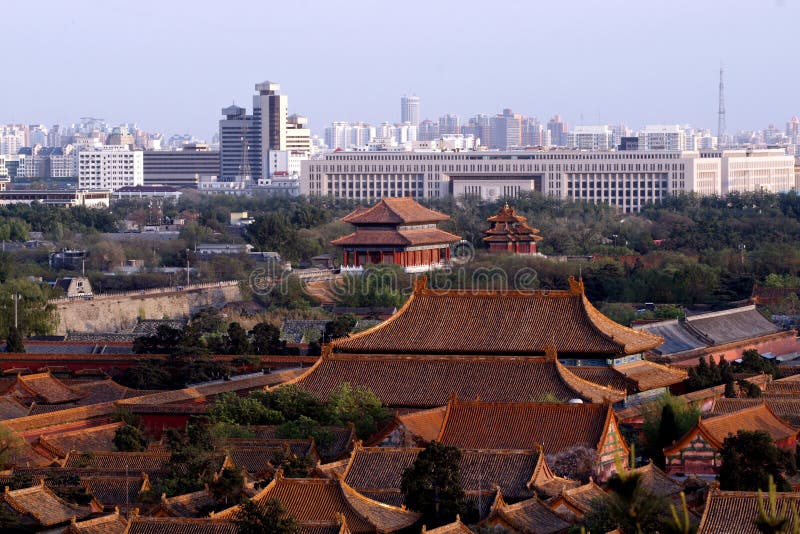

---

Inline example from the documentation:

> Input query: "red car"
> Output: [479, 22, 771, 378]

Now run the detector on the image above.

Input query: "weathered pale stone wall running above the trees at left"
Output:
[52, 282, 242, 334]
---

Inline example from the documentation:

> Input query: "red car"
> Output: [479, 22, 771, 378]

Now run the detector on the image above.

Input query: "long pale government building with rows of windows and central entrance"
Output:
[300, 149, 796, 212]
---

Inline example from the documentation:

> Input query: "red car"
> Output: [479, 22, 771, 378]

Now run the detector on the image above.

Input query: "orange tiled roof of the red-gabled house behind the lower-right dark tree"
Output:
[664, 403, 797, 455]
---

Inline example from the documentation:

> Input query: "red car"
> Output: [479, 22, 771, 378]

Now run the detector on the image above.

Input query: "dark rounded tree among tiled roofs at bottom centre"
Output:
[400, 441, 467, 527]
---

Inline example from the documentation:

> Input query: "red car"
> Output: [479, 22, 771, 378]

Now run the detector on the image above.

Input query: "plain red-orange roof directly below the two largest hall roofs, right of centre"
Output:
[437, 401, 616, 454]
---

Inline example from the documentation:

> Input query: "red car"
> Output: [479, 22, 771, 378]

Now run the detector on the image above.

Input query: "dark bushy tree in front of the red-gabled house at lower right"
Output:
[718, 430, 791, 491]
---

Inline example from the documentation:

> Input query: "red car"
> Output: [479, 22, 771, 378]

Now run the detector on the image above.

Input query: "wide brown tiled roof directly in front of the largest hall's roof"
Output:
[292, 354, 625, 408]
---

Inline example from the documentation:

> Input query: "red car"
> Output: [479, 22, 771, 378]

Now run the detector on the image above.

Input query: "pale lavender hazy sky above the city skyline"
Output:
[0, 0, 800, 138]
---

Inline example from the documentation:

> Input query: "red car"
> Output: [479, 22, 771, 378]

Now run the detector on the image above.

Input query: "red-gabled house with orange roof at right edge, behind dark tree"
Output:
[664, 404, 797, 475]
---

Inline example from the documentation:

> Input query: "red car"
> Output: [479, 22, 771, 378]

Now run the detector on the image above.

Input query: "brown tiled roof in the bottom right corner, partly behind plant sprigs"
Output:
[697, 490, 800, 534]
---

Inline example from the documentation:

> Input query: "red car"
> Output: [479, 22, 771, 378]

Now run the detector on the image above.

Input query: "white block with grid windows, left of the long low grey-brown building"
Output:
[78, 145, 144, 191]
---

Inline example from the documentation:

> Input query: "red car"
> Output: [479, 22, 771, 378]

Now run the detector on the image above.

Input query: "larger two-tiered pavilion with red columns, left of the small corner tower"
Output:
[332, 197, 461, 271]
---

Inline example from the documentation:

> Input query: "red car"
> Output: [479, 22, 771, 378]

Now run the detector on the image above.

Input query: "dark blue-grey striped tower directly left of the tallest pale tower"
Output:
[219, 105, 263, 182]
